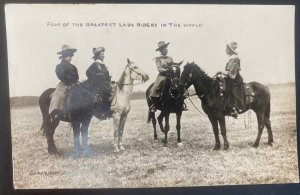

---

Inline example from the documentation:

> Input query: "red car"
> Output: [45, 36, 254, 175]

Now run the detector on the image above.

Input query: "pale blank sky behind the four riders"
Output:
[5, 4, 295, 97]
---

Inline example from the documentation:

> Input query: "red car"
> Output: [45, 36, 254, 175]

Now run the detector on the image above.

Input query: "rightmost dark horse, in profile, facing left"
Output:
[180, 63, 273, 150]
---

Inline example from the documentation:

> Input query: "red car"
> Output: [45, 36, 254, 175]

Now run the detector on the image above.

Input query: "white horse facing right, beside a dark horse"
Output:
[111, 59, 149, 152]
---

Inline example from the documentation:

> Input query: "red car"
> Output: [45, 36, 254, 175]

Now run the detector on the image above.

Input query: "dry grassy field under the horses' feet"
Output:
[11, 84, 299, 188]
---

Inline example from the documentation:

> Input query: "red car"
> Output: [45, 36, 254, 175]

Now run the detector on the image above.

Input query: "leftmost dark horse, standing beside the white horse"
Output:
[39, 71, 105, 156]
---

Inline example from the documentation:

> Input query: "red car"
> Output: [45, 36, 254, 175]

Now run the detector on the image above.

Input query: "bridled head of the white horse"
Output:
[125, 58, 149, 83]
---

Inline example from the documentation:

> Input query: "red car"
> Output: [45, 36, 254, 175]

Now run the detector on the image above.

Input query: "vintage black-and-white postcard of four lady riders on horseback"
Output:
[5, 4, 299, 189]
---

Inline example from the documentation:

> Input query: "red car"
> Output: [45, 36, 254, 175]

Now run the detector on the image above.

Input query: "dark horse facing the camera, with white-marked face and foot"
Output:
[146, 62, 184, 147]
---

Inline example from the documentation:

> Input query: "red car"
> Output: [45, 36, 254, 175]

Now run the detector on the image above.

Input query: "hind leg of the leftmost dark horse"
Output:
[44, 120, 59, 155]
